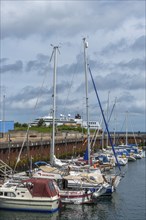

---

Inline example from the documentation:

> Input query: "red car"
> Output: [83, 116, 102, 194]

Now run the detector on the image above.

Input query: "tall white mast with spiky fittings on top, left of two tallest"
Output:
[50, 46, 58, 165]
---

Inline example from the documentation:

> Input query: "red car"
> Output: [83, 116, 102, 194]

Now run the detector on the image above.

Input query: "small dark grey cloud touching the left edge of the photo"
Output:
[1, 60, 23, 73]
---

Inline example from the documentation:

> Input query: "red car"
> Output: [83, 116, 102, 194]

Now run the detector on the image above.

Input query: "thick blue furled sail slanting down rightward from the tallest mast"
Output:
[88, 64, 121, 171]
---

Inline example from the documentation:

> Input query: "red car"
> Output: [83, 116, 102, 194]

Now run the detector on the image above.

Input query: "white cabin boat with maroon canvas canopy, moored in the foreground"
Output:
[0, 179, 60, 212]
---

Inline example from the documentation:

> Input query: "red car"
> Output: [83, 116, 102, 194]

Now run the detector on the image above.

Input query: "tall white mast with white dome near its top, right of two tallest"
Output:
[83, 38, 90, 165]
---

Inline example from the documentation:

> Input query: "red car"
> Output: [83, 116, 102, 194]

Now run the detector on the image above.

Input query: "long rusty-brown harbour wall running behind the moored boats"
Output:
[0, 131, 146, 167]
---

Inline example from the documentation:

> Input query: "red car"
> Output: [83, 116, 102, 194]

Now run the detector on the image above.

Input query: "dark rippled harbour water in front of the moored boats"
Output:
[0, 158, 146, 220]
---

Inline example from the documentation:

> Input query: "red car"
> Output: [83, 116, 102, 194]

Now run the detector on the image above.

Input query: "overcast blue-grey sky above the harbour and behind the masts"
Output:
[0, 0, 146, 131]
